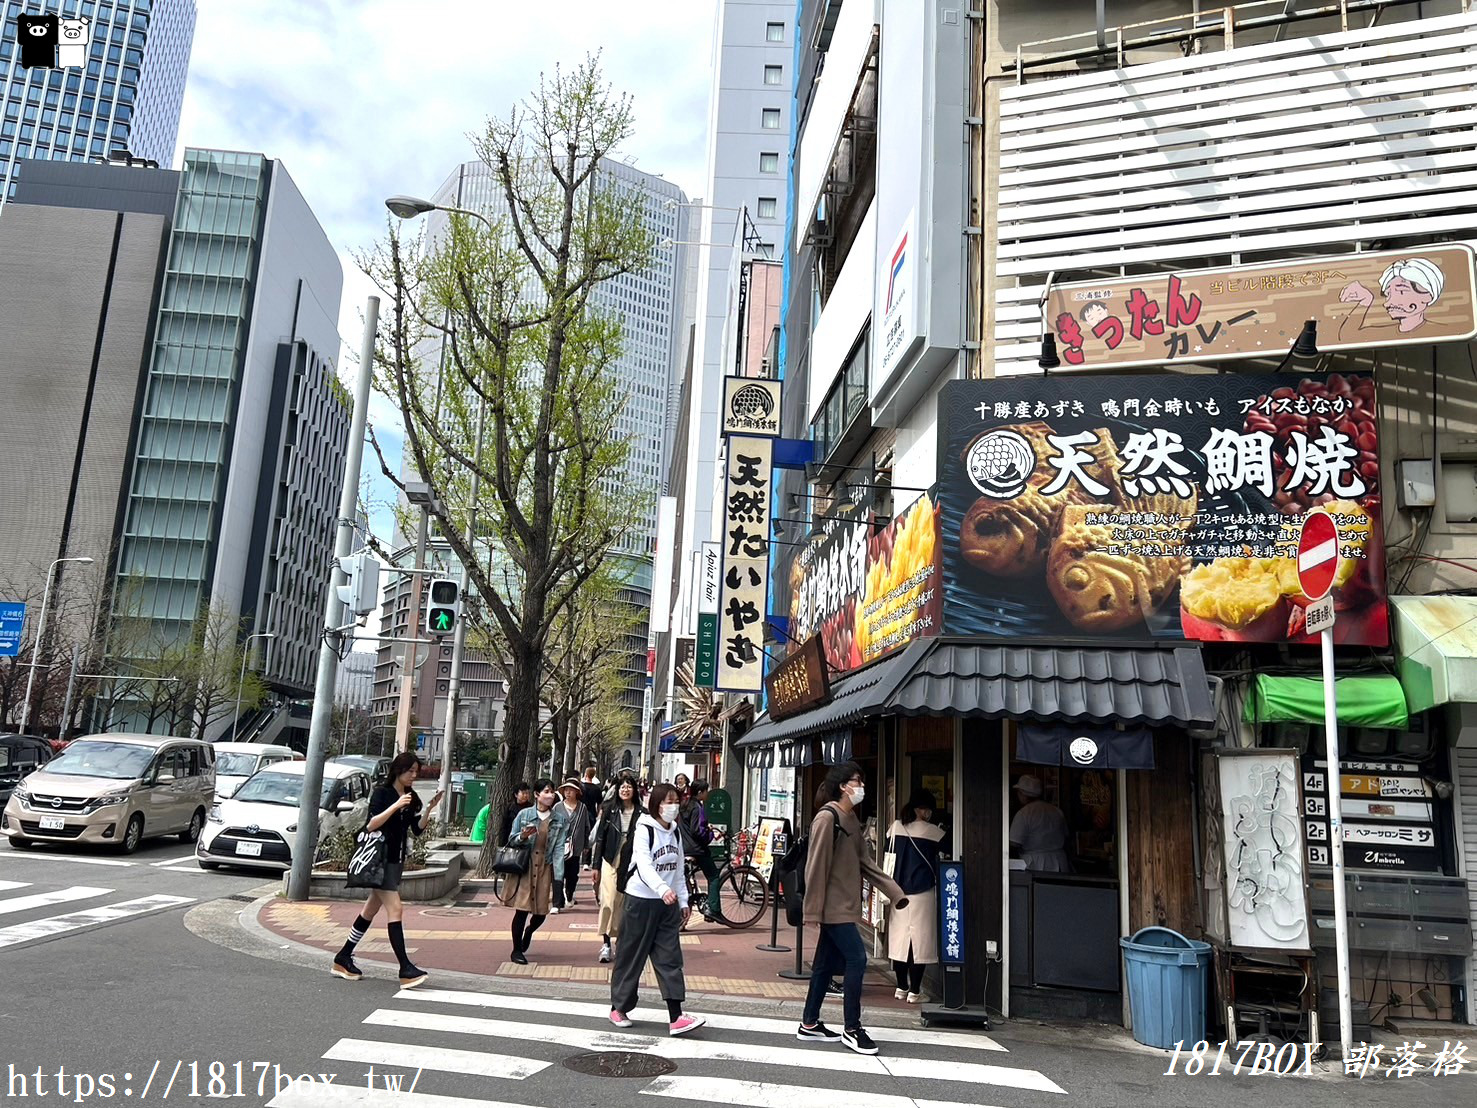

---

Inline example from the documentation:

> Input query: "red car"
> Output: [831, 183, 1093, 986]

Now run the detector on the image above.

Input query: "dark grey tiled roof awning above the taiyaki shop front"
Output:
[736, 637, 1216, 748]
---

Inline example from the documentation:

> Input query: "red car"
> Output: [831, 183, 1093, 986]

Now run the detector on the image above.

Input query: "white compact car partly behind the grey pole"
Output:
[195, 761, 371, 870]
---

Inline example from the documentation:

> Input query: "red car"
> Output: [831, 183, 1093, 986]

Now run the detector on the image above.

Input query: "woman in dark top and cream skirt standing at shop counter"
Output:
[888, 789, 944, 1005]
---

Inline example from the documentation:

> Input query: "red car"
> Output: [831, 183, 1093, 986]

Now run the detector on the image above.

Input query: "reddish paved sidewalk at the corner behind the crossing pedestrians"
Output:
[258, 873, 917, 1013]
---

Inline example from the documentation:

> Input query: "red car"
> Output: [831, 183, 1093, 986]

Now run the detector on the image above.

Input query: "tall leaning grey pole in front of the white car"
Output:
[287, 297, 380, 900]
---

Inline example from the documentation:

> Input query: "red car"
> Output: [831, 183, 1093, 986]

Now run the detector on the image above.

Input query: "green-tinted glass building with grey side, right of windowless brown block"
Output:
[114, 148, 352, 737]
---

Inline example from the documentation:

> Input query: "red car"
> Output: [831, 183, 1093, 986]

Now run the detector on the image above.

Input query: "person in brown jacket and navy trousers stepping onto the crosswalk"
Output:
[795, 762, 908, 1055]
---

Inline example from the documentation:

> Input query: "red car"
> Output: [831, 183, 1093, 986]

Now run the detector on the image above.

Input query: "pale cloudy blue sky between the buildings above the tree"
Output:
[179, 0, 715, 549]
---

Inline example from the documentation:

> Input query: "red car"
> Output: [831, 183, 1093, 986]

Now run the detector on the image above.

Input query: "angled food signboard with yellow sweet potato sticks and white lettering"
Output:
[789, 495, 942, 675]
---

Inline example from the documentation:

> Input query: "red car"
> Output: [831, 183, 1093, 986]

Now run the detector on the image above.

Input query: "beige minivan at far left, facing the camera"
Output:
[3, 734, 216, 854]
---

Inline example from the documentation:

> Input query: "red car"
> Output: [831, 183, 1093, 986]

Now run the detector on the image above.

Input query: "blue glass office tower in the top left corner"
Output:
[0, 0, 195, 205]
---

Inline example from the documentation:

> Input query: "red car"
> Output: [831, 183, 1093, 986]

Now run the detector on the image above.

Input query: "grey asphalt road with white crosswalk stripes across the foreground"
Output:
[0, 842, 1477, 1108]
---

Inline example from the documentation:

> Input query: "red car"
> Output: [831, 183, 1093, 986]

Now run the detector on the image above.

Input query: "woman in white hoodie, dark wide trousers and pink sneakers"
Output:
[610, 783, 707, 1036]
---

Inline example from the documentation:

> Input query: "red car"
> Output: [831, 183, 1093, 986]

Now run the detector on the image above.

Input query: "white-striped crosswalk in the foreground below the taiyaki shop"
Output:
[267, 987, 1066, 1108]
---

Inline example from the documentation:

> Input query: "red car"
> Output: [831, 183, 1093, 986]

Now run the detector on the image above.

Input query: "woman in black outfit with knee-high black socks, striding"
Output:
[332, 750, 442, 988]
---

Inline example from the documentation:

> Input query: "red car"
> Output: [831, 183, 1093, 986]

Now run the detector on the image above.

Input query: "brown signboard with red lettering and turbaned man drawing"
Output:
[1046, 244, 1477, 369]
